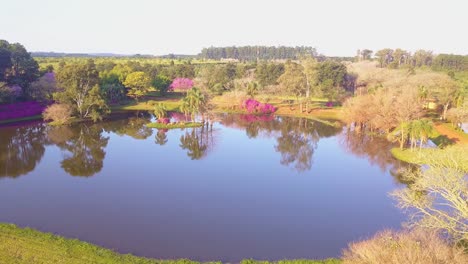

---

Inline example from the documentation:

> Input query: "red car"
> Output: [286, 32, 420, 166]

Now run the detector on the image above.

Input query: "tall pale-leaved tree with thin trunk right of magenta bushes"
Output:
[278, 61, 307, 112]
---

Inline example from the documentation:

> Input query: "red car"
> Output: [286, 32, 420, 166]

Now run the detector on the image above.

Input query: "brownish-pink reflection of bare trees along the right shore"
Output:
[340, 131, 410, 183]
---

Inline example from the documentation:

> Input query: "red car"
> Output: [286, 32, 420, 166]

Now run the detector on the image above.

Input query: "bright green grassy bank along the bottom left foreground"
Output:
[0, 223, 341, 264]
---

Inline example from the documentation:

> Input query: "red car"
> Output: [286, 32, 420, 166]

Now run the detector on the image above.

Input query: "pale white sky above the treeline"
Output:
[0, 0, 468, 56]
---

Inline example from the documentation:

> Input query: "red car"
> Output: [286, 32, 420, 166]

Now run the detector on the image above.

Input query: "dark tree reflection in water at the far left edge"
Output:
[0, 124, 47, 177]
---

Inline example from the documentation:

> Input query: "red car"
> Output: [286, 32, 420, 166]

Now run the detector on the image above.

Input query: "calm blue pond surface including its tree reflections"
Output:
[0, 115, 404, 262]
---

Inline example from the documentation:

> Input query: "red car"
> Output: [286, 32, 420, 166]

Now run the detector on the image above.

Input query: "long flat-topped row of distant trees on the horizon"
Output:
[199, 46, 317, 61]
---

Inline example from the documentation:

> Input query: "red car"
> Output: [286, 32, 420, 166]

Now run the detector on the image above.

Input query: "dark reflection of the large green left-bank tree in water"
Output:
[47, 123, 109, 177]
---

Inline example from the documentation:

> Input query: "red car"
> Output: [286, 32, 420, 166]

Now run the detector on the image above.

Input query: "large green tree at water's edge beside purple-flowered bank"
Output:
[53, 60, 109, 120]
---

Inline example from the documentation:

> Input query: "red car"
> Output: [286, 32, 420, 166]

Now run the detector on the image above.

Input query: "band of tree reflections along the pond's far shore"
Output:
[0, 113, 401, 179]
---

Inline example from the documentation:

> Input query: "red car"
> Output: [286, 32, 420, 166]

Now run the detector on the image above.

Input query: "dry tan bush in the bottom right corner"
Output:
[343, 229, 468, 264]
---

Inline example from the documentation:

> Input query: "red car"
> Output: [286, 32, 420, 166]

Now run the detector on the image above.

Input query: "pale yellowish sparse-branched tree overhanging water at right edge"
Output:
[392, 147, 468, 241]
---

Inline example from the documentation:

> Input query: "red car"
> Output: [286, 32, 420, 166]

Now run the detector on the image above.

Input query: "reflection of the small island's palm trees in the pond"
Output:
[179, 124, 214, 160]
